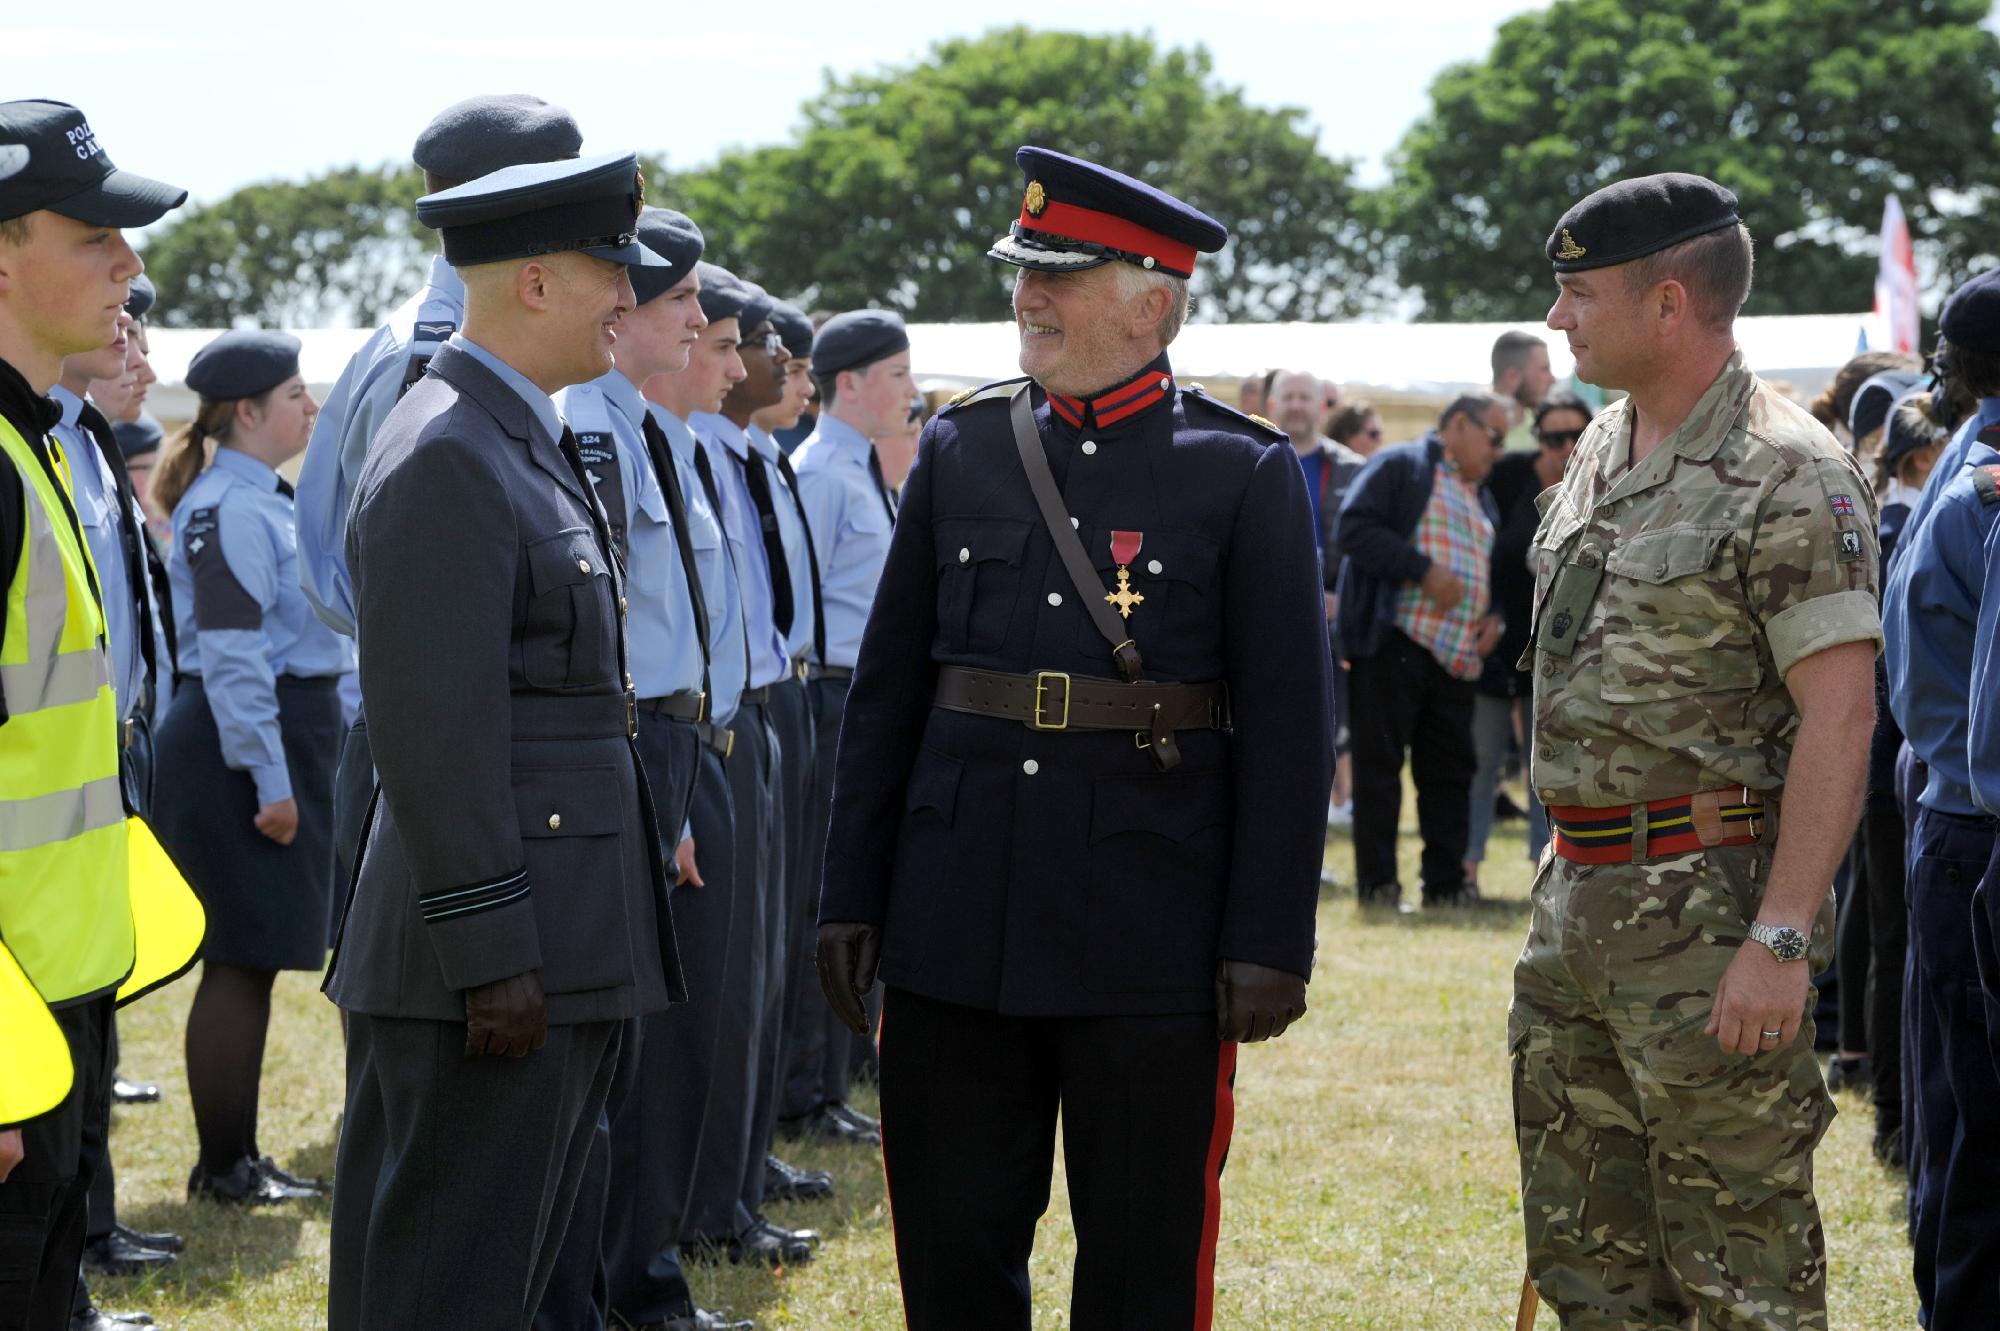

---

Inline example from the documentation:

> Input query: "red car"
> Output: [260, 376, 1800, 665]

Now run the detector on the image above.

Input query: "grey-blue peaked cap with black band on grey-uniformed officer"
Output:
[416, 152, 666, 268]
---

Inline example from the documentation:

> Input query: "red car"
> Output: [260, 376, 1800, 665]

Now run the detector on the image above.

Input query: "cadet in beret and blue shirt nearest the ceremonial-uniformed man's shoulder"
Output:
[786, 310, 916, 1143]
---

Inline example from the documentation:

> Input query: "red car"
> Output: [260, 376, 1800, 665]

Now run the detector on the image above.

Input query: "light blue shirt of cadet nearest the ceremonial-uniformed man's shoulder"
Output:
[792, 412, 894, 669]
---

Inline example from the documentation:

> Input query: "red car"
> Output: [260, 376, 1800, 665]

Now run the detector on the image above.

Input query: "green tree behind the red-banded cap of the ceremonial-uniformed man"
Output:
[664, 28, 1380, 322]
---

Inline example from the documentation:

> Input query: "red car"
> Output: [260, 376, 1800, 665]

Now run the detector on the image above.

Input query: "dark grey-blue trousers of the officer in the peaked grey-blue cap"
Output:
[326, 1013, 620, 1331]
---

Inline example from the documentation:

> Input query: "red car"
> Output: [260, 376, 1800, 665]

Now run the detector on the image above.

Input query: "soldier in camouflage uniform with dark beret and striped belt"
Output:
[1508, 176, 1880, 1331]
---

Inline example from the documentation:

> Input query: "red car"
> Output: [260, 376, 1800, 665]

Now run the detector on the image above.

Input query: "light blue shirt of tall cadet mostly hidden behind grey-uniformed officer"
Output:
[298, 256, 466, 638]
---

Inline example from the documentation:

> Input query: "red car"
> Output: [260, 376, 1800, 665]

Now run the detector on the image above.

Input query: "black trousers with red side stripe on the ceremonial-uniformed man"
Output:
[882, 989, 1236, 1331]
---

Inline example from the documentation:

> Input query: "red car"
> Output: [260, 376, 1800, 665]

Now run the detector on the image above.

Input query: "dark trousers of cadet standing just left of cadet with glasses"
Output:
[674, 705, 784, 1239]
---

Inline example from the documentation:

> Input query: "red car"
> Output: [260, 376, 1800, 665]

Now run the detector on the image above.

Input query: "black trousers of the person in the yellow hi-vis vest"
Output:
[0, 995, 112, 1331]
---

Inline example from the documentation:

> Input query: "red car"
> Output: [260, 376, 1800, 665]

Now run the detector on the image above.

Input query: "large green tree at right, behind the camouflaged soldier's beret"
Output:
[1370, 0, 2000, 320]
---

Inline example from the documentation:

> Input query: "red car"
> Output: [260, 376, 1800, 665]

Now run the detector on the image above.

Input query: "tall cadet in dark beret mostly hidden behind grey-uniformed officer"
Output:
[296, 94, 584, 931]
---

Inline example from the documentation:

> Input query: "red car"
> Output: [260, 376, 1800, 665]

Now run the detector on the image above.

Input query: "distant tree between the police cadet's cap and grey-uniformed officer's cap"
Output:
[144, 166, 436, 328]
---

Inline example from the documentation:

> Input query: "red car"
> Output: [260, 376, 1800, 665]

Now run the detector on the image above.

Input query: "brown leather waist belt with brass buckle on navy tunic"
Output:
[932, 666, 1230, 771]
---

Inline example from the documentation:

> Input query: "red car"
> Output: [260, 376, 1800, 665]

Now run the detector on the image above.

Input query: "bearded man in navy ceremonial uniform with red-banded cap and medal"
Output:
[818, 148, 1332, 1331]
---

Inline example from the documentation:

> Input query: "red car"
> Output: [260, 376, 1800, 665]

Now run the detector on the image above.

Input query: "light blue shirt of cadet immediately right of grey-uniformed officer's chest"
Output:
[560, 370, 706, 697]
